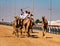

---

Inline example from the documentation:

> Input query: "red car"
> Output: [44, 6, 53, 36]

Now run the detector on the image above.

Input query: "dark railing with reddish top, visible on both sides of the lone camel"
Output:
[35, 25, 60, 34]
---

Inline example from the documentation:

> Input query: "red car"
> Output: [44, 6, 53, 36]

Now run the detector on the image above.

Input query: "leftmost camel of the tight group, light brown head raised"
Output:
[12, 16, 19, 37]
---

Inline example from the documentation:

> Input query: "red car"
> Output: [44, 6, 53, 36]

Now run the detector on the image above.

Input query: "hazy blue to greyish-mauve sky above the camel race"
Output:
[0, 0, 60, 22]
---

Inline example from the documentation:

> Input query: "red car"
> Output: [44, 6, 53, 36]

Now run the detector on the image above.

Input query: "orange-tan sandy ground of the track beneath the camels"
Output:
[0, 25, 60, 46]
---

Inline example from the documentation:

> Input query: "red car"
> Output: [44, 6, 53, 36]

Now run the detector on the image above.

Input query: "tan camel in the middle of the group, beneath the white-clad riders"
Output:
[21, 19, 33, 37]
